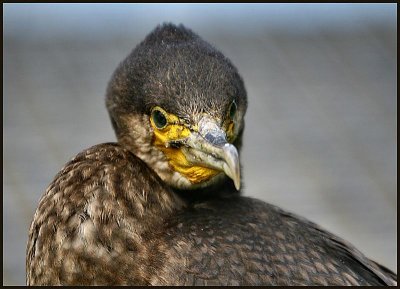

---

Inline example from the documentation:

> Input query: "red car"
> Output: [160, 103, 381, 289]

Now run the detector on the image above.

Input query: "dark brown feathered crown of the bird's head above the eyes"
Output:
[106, 24, 247, 132]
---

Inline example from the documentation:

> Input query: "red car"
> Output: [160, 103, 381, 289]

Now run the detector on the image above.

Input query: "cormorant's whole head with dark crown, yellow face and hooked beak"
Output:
[106, 24, 247, 190]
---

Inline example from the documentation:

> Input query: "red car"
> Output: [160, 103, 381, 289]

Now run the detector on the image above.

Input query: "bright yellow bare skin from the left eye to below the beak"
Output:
[150, 112, 220, 184]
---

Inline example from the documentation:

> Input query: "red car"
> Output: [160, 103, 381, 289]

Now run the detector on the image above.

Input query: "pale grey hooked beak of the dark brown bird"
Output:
[175, 116, 240, 190]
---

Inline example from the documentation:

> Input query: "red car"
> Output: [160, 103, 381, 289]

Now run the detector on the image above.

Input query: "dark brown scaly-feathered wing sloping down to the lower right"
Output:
[152, 197, 396, 285]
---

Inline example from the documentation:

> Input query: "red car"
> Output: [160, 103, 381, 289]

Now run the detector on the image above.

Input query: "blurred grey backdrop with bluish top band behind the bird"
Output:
[3, 4, 397, 285]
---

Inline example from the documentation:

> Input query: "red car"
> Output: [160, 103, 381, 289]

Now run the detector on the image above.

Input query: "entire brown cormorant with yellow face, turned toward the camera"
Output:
[26, 23, 397, 285]
